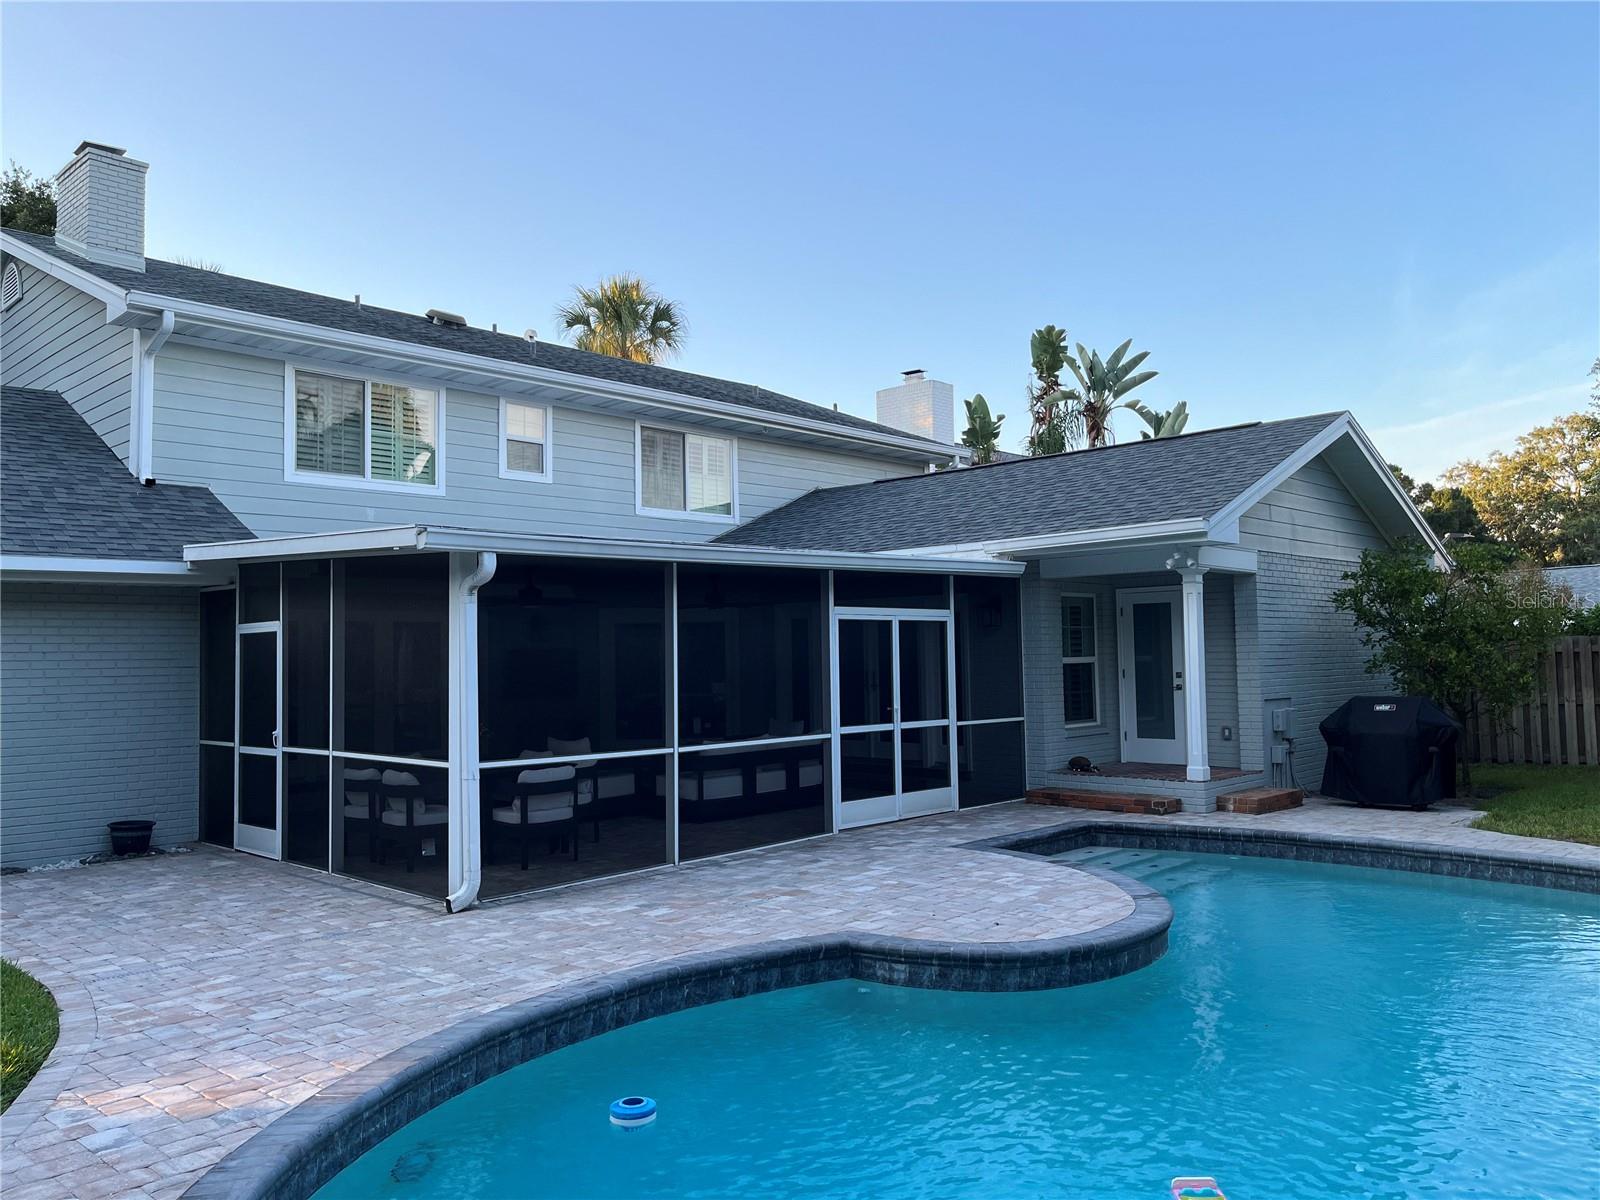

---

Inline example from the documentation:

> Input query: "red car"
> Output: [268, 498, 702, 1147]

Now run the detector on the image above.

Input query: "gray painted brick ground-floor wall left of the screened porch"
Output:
[0, 584, 200, 867]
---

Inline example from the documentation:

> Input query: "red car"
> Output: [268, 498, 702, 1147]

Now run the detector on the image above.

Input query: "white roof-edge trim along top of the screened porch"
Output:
[184, 525, 1026, 579]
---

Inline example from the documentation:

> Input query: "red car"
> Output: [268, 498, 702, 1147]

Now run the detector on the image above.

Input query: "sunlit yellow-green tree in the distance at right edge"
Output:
[1445, 411, 1600, 563]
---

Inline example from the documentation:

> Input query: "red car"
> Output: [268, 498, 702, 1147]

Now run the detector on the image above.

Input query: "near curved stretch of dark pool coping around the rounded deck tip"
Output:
[182, 867, 1173, 1200]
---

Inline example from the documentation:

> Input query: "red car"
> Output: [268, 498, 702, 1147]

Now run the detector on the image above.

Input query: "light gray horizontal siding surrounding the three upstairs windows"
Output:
[155, 344, 909, 541]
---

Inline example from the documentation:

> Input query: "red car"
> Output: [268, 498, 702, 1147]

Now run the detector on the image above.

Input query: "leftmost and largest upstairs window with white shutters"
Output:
[291, 370, 440, 488]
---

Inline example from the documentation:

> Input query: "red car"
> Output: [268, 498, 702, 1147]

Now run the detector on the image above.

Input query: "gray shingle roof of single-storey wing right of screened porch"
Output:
[717, 413, 1342, 550]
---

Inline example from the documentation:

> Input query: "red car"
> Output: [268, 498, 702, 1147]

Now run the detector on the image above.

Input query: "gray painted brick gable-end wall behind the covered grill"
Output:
[1256, 550, 1390, 790]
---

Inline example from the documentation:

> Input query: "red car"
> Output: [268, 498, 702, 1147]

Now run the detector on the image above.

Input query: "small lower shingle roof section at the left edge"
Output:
[0, 387, 253, 562]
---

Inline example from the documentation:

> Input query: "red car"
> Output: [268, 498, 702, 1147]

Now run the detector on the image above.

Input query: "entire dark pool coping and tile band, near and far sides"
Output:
[182, 818, 1600, 1200]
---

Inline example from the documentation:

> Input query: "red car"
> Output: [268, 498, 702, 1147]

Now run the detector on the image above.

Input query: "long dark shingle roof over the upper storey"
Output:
[5, 229, 947, 450]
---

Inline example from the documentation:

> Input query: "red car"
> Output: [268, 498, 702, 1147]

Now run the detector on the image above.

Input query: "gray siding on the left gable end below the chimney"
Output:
[0, 262, 136, 462]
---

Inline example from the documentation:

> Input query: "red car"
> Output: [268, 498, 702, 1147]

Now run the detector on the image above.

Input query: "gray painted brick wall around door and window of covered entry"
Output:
[1022, 566, 1240, 787]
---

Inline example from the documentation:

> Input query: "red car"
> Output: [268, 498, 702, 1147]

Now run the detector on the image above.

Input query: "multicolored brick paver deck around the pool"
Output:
[0, 802, 1600, 1200]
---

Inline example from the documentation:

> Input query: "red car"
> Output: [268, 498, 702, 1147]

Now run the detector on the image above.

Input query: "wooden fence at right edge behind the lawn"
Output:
[1467, 637, 1600, 766]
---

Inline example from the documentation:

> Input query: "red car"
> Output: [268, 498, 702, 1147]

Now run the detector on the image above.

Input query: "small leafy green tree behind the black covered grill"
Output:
[1333, 544, 1570, 790]
